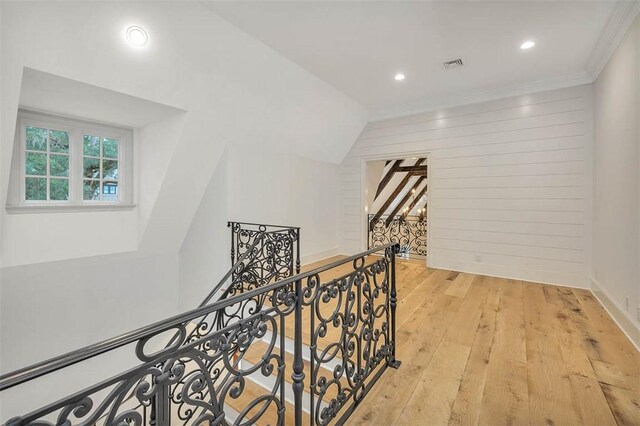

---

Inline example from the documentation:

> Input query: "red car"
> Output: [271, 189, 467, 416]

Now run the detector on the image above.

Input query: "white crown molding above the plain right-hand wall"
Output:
[585, 0, 640, 81]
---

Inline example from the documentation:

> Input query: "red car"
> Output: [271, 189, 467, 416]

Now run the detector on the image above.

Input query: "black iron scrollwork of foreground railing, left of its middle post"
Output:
[6, 286, 295, 426]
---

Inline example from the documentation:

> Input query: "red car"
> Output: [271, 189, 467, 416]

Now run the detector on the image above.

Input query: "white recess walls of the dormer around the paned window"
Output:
[2, 67, 185, 266]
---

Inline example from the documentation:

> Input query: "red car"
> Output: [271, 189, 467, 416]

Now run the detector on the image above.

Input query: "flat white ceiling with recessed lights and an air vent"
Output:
[207, 1, 628, 118]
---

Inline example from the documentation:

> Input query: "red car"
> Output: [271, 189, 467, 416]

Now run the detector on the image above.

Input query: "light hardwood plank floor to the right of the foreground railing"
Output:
[347, 261, 640, 425]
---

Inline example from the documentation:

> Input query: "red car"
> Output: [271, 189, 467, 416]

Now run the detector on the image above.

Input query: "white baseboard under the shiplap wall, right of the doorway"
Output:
[427, 256, 590, 290]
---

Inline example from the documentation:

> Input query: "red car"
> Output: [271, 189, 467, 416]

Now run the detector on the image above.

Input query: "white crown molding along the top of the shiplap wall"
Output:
[369, 71, 593, 122]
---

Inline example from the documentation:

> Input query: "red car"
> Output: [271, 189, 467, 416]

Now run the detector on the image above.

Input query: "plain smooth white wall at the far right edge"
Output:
[593, 18, 640, 346]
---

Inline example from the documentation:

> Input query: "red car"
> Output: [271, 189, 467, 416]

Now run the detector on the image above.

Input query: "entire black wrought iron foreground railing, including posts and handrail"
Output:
[0, 244, 400, 426]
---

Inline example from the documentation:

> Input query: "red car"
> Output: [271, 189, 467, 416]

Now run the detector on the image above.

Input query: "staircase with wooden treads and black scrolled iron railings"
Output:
[0, 222, 399, 426]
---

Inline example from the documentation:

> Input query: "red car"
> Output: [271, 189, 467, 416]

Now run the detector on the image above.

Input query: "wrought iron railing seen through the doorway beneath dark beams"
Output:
[367, 214, 427, 258]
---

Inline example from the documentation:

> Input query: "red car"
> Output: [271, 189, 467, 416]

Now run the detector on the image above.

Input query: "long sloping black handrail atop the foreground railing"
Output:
[0, 243, 396, 391]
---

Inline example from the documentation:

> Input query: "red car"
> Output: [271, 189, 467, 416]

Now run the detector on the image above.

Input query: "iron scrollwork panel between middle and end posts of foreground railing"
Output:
[302, 245, 400, 425]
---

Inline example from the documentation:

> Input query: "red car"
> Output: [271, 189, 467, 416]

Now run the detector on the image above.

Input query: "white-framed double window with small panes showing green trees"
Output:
[7, 110, 133, 212]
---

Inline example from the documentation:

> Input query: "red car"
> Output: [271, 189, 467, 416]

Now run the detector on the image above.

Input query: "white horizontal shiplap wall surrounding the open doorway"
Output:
[341, 85, 593, 286]
